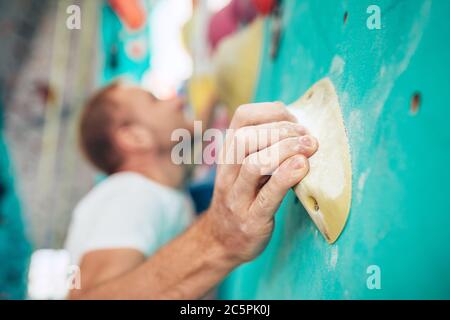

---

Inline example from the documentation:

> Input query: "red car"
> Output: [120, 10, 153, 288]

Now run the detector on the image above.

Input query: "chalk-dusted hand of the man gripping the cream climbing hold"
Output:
[207, 103, 318, 263]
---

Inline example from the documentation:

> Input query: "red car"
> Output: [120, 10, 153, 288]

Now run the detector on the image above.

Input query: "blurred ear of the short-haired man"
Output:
[114, 125, 156, 152]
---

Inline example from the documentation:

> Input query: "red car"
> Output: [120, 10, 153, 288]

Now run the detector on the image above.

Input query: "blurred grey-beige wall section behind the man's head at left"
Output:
[0, 0, 97, 248]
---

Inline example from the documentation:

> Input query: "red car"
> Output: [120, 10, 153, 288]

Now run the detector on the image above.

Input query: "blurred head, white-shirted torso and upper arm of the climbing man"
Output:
[66, 83, 193, 296]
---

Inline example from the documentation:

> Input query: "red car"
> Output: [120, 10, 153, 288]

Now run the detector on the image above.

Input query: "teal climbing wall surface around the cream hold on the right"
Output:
[220, 0, 450, 299]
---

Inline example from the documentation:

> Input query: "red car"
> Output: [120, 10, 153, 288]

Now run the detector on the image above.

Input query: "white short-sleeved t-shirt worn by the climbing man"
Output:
[65, 172, 194, 264]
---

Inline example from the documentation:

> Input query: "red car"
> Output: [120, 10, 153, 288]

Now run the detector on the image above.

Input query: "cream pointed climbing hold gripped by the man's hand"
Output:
[288, 78, 352, 243]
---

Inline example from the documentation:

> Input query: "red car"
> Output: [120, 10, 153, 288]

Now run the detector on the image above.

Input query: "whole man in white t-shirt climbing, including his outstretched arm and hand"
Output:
[66, 83, 317, 299]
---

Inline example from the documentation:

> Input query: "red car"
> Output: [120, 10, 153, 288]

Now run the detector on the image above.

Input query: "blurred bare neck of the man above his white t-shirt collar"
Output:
[118, 153, 185, 189]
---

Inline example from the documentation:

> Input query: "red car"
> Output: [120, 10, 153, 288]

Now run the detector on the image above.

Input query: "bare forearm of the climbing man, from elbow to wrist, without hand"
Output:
[74, 213, 238, 299]
